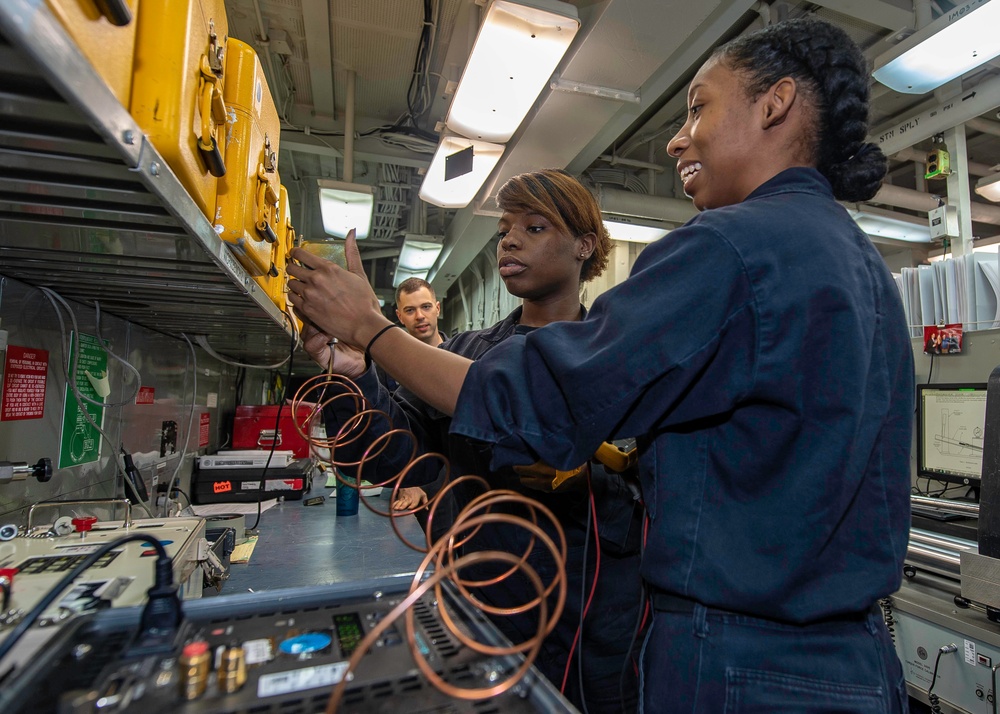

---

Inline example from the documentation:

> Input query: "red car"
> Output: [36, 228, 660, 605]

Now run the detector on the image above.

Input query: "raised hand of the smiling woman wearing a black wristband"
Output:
[288, 230, 386, 350]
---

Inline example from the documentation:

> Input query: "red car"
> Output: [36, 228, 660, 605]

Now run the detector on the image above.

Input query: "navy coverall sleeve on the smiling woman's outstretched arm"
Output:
[451, 219, 757, 469]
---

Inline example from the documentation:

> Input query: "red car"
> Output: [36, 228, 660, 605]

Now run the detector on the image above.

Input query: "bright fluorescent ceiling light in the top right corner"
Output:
[872, 0, 1000, 94]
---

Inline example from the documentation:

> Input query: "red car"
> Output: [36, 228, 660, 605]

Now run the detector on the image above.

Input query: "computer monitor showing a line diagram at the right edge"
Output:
[917, 382, 986, 488]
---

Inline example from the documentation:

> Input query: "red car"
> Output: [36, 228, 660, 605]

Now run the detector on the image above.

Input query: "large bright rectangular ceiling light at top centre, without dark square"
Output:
[445, 0, 580, 144]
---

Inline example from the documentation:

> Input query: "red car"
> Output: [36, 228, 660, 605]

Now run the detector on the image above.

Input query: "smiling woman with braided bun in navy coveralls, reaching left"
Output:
[289, 20, 913, 713]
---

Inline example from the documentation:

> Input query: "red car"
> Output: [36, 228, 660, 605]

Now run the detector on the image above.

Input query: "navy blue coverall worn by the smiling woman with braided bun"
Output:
[451, 168, 914, 712]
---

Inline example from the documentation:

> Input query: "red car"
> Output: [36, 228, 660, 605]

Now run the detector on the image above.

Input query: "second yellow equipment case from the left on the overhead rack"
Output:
[130, 0, 229, 221]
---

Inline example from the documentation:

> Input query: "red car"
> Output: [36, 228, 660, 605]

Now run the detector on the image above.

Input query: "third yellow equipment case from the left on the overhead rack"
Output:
[215, 38, 281, 282]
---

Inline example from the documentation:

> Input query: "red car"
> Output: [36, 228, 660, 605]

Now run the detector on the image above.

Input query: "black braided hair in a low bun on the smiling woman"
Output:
[713, 18, 886, 201]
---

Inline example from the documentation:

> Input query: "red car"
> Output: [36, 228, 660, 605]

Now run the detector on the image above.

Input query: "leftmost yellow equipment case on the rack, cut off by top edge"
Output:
[46, 0, 138, 107]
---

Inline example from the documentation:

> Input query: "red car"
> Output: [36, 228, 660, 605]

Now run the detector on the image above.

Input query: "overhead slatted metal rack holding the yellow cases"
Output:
[0, 0, 292, 364]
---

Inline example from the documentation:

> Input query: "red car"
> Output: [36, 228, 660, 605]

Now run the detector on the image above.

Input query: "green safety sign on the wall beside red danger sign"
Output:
[59, 333, 108, 469]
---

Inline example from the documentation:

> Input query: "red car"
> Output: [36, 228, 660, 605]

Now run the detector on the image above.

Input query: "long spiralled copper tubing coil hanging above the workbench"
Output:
[292, 373, 566, 712]
